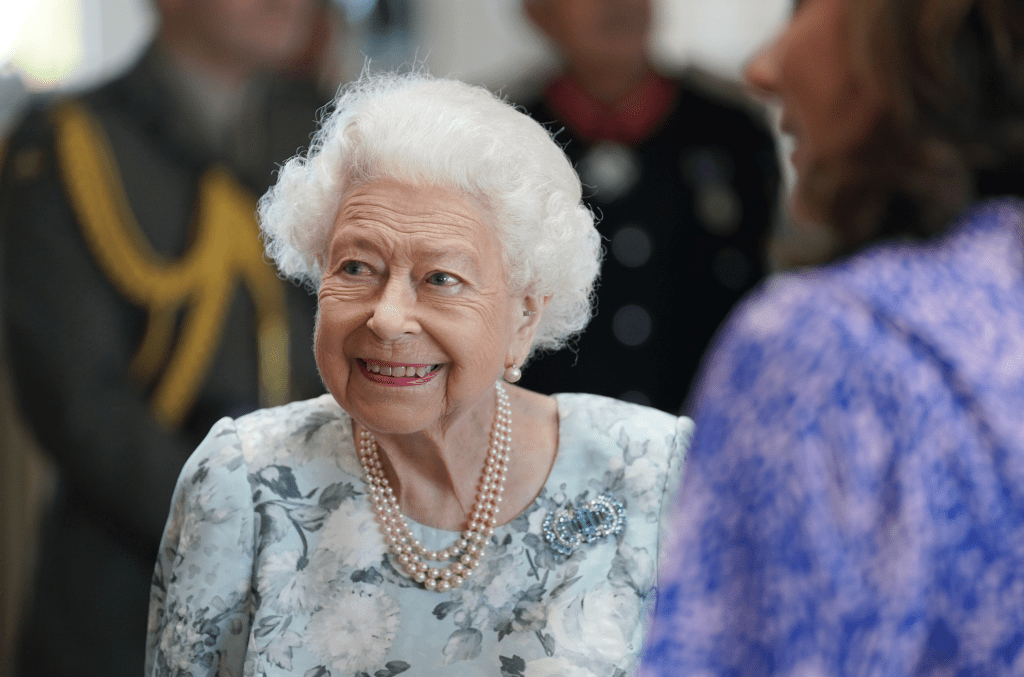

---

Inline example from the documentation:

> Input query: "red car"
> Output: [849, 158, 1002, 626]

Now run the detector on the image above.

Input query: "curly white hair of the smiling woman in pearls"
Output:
[259, 72, 601, 354]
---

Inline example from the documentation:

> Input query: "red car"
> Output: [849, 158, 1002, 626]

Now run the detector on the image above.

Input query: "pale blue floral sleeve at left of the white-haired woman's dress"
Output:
[145, 418, 256, 677]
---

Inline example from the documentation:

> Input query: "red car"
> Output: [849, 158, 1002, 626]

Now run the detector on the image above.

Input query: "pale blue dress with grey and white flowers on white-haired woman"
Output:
[146, 394, 692, 677]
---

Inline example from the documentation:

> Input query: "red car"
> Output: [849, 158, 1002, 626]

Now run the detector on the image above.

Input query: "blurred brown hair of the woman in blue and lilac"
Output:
[804, 0, 1024, 256]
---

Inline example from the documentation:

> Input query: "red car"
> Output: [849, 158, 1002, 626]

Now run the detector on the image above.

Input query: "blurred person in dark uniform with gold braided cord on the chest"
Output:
[0, 0, 329, 677]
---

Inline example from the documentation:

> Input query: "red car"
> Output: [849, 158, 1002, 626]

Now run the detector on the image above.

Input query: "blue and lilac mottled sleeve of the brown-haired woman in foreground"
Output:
[642, 278, 908, 677]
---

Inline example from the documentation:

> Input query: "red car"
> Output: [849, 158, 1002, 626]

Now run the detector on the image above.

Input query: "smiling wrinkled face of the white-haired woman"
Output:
[315, 181, 538, 434]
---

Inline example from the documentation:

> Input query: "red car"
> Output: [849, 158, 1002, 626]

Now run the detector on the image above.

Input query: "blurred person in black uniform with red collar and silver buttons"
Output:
[523, 0, 778, 412]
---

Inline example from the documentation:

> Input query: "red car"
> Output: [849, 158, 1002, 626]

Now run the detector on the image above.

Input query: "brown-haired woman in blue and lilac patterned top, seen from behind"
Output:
[644, 0, 1024, 677]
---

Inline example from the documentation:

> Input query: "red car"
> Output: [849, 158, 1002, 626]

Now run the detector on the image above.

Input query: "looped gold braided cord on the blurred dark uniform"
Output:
[54, 102, 289, 427]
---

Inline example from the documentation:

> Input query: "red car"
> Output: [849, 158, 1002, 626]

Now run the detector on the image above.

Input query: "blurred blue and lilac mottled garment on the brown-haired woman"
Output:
[643, 201, 1024, 677]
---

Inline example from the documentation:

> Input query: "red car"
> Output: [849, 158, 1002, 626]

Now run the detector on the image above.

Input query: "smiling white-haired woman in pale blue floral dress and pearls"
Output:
[142, 75, 690, 676]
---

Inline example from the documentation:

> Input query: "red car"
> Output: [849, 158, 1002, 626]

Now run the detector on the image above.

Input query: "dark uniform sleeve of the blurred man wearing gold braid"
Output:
[0, 116, 195, 552]
